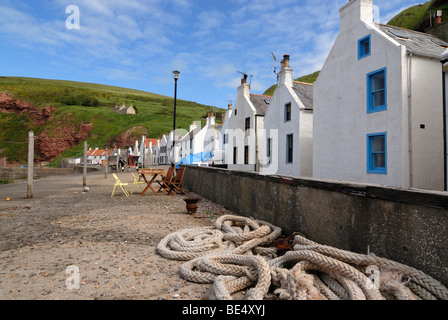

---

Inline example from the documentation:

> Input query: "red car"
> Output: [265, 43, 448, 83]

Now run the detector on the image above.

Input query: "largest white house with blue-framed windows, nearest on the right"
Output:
[313, 0, 448, 190]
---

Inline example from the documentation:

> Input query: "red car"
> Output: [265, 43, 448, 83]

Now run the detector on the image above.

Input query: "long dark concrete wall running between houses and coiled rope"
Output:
[183, 166, 448, 286]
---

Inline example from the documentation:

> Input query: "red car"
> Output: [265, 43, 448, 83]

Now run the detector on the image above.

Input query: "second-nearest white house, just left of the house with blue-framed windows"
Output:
[262, 55, 313, 177]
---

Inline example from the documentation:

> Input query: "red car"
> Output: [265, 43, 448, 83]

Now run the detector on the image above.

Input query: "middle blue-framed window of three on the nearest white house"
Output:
[367, 69, 387, 113]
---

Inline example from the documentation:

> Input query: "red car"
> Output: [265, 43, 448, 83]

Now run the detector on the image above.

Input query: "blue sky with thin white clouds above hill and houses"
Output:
[0, 0, 425, 108]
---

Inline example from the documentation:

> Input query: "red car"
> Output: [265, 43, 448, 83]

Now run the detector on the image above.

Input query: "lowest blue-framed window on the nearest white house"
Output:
[367, 133, 387, 174]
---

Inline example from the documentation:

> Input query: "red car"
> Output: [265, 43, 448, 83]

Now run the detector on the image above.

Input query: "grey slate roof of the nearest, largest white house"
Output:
[378, 24, 448, 60]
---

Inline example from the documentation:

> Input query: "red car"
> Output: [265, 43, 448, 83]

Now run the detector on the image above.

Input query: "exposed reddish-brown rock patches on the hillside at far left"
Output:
[0, 93, 93, 162]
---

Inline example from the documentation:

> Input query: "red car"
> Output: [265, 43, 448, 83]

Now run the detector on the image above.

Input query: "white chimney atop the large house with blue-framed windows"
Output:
[339, 0, 373, 31]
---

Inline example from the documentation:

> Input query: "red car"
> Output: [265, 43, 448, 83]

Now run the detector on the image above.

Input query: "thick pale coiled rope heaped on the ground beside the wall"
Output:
[157, 215, 448, 300]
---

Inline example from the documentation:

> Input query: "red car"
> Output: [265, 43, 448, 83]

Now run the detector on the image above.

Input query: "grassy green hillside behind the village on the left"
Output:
[0, 77, 223, 163]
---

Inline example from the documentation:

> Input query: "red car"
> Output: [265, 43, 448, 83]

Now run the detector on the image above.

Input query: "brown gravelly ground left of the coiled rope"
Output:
[0, 172, 231, 300]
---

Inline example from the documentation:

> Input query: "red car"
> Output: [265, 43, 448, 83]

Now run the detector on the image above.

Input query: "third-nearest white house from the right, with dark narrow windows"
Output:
[224, 75, 272, 172]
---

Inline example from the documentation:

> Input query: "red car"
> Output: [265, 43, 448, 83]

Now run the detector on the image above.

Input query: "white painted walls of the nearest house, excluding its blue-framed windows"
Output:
[313, 0, 443, 190]
